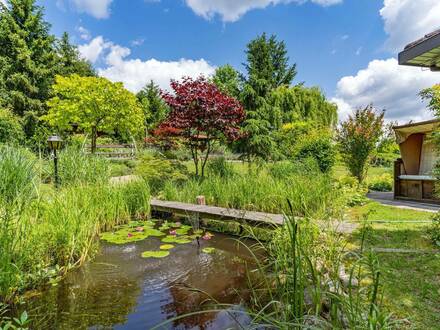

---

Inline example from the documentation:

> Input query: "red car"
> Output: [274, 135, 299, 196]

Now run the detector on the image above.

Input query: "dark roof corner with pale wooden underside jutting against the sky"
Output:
[399, 29, 440, 71]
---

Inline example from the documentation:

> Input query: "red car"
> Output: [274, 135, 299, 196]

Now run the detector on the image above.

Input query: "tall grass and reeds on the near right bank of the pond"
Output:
[239, 208, 398, 329]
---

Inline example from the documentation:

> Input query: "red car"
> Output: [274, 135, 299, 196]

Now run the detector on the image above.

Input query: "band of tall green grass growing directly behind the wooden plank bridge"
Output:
[160, 163, 342, 219]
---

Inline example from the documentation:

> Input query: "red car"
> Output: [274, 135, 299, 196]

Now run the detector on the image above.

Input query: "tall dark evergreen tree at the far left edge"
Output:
[0, 0, 57, 136]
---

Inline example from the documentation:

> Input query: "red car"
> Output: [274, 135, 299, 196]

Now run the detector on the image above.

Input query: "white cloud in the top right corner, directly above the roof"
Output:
[380, 0, 440, 52]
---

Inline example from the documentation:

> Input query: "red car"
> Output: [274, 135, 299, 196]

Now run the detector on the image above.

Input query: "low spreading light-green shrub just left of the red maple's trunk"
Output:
[135, 153, 187, 193]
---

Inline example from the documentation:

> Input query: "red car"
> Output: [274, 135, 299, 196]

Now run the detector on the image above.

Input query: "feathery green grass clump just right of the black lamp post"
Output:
[58, 147, 110, 185]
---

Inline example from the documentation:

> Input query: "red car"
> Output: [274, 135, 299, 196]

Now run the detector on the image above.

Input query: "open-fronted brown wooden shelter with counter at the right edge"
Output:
[393, 120, 440, 202]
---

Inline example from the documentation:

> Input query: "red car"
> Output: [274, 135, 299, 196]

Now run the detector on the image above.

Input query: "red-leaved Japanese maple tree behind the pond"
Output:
[157, 76, 245, 177]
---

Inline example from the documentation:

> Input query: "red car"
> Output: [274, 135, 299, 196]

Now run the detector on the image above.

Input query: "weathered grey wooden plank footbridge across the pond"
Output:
[151, 199, 284, 225]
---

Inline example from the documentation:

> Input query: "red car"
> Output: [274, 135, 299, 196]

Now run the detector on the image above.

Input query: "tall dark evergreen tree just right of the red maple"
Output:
[237, 33, 296, 160]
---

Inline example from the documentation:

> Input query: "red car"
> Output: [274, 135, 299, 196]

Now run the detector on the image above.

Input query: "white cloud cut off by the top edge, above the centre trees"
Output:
[185, 0, 343, 22]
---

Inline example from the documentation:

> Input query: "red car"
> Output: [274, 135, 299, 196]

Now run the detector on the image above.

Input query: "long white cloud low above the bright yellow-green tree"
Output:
[78, 36, 215, 92]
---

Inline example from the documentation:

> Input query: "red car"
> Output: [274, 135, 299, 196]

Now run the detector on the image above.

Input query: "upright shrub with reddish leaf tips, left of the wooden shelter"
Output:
[337, 105, 384, 182]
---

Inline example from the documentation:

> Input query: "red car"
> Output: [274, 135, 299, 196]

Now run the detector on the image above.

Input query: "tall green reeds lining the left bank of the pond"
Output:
[0, 147, 150, 301]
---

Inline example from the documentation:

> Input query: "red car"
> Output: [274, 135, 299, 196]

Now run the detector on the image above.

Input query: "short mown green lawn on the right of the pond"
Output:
[349, 202, 440, 329]
